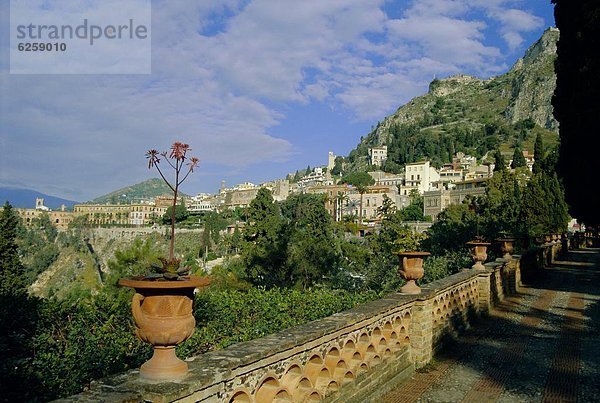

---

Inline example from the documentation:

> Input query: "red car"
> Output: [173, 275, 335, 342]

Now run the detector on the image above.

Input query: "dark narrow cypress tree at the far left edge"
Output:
[0, 202, 27, 295]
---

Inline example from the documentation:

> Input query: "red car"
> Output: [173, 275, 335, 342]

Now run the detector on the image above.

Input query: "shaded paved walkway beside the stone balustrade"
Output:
[382, 249, 600, 403]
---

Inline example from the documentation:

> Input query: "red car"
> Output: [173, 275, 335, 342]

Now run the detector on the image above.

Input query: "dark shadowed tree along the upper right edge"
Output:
[552, 0, 600, 225]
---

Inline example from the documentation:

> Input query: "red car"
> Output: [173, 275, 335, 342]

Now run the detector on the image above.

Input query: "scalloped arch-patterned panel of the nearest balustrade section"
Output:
[226, 308, 411, 403]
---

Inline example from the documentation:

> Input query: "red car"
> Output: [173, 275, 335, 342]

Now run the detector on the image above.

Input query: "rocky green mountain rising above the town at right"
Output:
[344, 28, 559, 172]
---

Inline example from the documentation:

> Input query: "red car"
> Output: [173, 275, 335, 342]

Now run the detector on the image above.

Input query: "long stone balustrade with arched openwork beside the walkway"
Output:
[63, 242, 561, 402]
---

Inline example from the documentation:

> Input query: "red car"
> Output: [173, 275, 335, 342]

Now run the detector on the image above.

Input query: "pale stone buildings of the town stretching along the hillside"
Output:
[17, 146, 534, 229]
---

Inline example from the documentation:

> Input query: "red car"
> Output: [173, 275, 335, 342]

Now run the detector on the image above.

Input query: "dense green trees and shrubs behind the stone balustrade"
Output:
[0, 139, 568, 400]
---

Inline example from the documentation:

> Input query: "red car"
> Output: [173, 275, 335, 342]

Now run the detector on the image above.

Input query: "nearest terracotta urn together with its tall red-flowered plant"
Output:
[119, 142, 209, 381]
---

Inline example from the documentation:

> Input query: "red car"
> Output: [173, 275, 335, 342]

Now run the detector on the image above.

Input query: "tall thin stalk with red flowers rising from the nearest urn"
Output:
[146, 141, 199, 272]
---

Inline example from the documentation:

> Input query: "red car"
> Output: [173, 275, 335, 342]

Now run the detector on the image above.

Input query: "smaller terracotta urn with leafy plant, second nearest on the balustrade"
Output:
[392, 229, 430, 294]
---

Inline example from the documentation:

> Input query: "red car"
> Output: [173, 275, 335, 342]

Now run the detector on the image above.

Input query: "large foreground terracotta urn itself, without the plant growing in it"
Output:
[119, 276, 209, 380]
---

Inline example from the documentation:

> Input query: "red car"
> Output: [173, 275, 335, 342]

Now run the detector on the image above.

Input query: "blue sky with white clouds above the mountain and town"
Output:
[0, 0, 554, 200]
